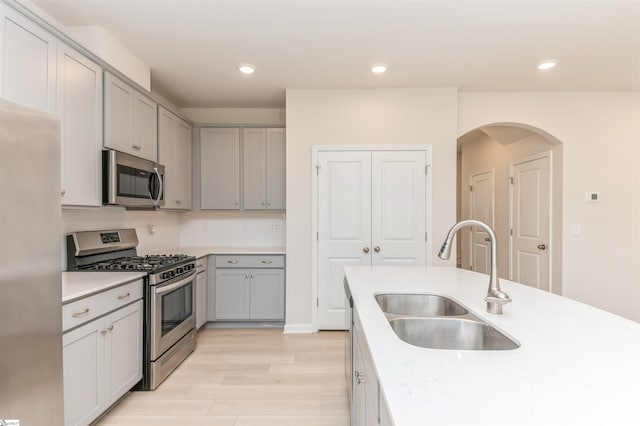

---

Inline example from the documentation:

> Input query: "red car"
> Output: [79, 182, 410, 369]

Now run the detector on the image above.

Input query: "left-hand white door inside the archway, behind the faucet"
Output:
[469, 170, 495, 274]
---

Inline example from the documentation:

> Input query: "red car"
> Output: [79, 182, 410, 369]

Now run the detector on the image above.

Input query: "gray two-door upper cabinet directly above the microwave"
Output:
[104, 72, 158, 161]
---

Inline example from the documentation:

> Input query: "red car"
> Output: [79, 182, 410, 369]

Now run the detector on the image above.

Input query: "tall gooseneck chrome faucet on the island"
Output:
[438, 219, 511, 314]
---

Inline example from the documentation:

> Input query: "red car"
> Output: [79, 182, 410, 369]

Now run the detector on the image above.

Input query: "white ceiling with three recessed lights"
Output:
[31, 0, 640, 107]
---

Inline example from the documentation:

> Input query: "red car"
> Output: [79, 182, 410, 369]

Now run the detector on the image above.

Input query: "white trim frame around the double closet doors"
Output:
[309, 145, 433, 332]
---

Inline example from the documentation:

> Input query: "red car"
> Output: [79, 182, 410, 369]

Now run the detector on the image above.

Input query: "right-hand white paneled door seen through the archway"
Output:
[511, 154, 551, 291]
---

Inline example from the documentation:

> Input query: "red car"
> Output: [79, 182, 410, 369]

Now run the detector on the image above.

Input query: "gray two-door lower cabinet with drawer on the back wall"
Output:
[214, 255, 285, 321]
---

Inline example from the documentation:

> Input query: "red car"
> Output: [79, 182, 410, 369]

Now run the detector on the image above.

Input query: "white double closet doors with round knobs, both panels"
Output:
[316, 151, 427, 330]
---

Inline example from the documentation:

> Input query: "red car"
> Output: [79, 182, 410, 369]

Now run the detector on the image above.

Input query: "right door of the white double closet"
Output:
[371, 151, 426, 266]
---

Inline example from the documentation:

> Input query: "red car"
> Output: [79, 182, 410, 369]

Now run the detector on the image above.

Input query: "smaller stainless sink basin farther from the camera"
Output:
[375, 293, 469, 317]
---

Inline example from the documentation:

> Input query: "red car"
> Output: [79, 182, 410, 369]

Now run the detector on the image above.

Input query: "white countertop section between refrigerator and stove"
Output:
[62, 271, 147, 305]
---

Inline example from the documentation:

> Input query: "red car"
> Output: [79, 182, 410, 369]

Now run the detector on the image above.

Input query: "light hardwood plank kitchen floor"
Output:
[97, 329, 349, 426]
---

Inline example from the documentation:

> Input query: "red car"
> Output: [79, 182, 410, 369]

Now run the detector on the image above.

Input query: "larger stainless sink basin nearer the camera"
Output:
[389, 317, 520, 350]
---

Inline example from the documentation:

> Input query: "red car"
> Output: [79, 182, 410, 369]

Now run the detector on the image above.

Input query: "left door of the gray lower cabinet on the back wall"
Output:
[215, 269, 251, 320]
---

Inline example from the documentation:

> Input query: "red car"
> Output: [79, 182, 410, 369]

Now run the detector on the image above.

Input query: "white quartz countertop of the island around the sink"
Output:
[345, 266, 640, 426]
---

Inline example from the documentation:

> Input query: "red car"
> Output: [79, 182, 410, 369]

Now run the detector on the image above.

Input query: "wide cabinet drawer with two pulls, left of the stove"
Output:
[62, 280, 142, 331]
